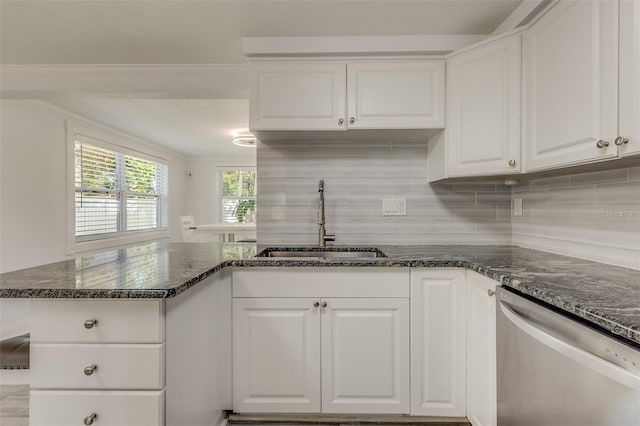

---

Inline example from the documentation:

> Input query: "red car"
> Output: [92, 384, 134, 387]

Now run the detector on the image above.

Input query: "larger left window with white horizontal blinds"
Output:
[73, 135, 168, 242]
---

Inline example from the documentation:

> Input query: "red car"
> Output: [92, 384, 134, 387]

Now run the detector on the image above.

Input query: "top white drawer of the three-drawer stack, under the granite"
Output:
[31, 299, 164, 343]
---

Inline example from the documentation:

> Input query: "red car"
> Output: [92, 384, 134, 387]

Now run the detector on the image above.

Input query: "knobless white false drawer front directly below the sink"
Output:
[233, 267, 409, 297]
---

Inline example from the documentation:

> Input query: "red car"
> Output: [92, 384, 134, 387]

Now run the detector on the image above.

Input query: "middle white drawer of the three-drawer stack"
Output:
[31, 343, 164, 389]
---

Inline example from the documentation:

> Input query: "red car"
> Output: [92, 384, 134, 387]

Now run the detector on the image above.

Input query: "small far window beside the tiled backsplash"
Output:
[219, 168, 256, 223]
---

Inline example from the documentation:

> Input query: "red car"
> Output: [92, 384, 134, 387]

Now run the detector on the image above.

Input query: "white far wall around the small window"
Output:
[187, 156, 256, 225]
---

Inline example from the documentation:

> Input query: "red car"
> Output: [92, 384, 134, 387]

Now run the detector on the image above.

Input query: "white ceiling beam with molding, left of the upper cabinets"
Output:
[0, 64, 249, 99]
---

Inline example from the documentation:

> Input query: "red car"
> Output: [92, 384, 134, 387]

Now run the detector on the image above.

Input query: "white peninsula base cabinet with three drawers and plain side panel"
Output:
[29, 271, 231, 426]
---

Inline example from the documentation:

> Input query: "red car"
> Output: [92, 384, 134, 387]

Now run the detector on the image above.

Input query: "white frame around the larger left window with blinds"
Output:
[66, 121, 170, 255]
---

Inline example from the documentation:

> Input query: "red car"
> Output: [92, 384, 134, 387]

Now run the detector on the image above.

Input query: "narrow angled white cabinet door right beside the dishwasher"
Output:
[467, 271, 498, 426]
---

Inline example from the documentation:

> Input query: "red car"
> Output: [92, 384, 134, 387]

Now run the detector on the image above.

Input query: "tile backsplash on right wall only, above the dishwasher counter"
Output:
[511, 167, 640, 269]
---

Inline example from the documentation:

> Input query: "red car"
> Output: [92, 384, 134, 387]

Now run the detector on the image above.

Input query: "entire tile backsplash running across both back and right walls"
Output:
[257, 140, 640, 269]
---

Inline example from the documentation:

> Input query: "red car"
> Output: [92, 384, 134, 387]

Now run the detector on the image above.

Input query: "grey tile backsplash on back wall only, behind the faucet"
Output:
[257, 140, 510, 244]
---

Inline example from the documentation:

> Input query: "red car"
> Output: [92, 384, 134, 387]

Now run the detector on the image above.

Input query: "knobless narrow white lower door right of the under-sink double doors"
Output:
[411, 268, 465, 416]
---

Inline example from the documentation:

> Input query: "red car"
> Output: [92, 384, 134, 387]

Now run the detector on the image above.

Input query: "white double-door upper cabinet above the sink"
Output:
[249, 59, 444, 132]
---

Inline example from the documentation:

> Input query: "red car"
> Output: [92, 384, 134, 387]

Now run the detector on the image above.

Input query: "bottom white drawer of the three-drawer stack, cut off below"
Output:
[29, 390, 164, 426]
